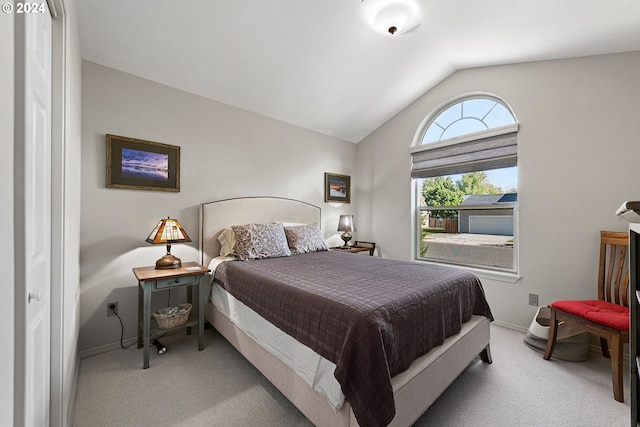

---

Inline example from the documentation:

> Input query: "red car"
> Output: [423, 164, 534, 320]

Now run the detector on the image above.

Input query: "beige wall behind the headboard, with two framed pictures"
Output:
[79, 61, 357, 351]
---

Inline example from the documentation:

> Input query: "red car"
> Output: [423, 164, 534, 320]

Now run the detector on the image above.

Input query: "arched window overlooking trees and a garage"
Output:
[411, 95, 518, 272]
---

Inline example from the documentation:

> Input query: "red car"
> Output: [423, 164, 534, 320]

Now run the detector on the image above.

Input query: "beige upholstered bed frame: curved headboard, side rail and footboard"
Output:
[199, 197, 491, 427]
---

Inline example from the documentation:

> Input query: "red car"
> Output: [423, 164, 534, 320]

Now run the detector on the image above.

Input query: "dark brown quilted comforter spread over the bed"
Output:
[214, 251, 492, 426]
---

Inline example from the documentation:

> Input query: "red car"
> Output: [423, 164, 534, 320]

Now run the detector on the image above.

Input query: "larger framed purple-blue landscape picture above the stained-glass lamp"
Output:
[107, 134, 180, 192]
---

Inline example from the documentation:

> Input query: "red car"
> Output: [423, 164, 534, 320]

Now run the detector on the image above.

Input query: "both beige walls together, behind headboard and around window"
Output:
[80, 52, 640, 350]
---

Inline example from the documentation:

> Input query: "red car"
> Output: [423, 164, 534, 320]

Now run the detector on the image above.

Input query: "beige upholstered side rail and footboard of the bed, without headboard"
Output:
[205, 301, 490, 427]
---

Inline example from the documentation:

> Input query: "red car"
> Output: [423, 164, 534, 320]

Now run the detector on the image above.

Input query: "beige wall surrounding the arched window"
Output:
[355, 52, 640, 327]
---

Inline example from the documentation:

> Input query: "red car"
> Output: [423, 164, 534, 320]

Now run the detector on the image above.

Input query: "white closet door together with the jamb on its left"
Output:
[14, 6, 52, 426]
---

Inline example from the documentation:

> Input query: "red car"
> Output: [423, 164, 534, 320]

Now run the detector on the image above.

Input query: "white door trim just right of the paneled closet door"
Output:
[47, 0, 80, 427]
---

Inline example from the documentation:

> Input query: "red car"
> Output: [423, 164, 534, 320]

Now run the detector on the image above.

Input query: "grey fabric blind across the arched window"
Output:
[411, 131, 518, 178]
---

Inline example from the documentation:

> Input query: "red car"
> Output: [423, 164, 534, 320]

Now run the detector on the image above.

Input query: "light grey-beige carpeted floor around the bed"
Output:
[74, 324, 630, 427]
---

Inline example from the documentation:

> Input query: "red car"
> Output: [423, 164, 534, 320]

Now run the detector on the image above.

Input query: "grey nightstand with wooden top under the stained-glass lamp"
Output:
[133, 262, 209, 369]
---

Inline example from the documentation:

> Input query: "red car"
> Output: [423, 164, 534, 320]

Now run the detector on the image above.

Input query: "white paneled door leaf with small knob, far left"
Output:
[17, 6, 52, 426]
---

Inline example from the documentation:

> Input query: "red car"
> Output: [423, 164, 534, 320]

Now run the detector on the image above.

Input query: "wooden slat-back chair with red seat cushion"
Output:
[544, 231, 630, 402]
